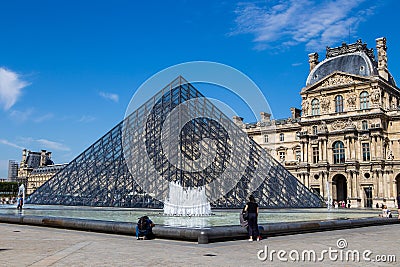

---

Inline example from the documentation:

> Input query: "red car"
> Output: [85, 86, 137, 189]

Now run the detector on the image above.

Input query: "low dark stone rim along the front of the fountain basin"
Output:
[0, 214, 400, 244]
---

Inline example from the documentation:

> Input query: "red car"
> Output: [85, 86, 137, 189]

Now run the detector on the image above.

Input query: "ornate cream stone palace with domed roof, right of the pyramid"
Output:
[238, 38, 400, 207]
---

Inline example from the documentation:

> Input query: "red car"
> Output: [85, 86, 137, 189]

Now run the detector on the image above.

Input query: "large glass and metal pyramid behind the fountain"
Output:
[27, 77, 323, 208]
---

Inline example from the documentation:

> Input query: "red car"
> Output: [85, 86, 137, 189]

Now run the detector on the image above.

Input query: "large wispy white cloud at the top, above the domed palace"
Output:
[231, 0, 375, 51]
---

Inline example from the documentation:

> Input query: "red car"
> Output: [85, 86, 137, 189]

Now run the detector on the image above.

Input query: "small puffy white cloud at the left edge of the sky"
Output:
[0, 68, 29, 110]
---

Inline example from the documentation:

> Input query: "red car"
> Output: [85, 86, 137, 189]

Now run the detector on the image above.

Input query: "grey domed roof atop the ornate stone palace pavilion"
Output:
[306, 40, 396, 86]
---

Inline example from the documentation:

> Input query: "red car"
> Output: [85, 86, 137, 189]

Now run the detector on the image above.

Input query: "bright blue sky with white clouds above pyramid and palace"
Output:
[0, 0, 400, 177]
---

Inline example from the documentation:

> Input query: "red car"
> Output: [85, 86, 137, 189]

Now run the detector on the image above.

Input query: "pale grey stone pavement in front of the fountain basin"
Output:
[0, 223, 400, 267]
